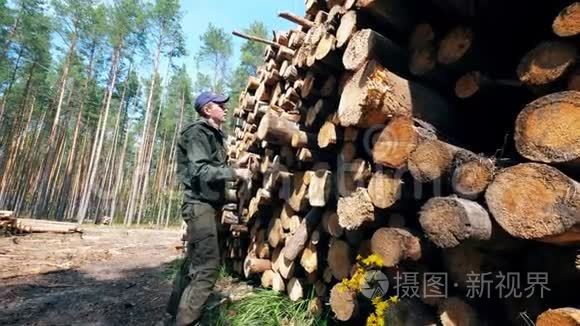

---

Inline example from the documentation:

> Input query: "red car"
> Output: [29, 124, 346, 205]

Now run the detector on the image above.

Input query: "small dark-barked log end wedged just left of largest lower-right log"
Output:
[451, 152, 495, 199]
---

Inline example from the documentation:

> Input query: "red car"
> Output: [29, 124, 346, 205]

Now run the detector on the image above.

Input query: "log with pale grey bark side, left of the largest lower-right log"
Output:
[419, 196, 492, 248]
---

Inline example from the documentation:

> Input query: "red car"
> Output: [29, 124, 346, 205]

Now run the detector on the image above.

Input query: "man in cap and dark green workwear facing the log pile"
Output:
[167, 92, 251, 325]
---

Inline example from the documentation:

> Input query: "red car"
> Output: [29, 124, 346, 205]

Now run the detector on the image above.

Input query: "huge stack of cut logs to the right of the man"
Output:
[222, 0, 580, 325]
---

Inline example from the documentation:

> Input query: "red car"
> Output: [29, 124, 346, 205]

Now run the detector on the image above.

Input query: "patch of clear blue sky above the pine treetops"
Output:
[167, 0, 304, 81]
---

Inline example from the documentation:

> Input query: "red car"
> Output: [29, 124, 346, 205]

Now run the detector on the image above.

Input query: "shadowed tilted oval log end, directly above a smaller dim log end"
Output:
[437, 26, 474, 65]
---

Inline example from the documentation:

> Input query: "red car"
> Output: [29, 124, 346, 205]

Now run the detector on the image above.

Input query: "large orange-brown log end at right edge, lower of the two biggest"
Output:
[485, 163, 580, 244]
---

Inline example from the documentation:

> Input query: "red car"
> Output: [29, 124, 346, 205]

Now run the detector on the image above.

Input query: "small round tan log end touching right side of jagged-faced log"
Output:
[368, 170, 402, 209]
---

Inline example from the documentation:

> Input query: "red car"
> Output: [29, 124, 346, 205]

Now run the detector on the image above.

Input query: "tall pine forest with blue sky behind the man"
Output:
[0, 0, 303, 226]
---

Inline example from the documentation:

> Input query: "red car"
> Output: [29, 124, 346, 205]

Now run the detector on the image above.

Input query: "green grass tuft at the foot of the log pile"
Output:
[202, 289, 327, 326]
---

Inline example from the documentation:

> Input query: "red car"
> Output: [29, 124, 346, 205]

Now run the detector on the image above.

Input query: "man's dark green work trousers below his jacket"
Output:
[167, 202, 220, 326]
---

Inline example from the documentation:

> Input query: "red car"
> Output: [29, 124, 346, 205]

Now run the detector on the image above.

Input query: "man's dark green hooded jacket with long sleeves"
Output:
[177, 118, 235, 205]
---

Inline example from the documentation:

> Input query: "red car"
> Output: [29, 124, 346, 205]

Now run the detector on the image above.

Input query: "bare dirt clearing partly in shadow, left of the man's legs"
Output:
[0, 226, 186, 325]
